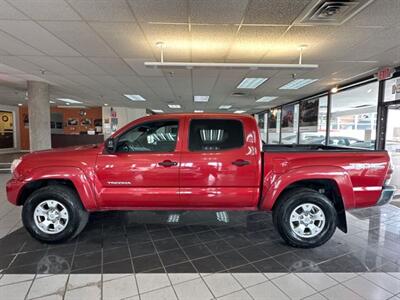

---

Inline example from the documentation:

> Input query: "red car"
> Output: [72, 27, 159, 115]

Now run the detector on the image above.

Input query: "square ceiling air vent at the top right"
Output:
[297, 0, 374, 25]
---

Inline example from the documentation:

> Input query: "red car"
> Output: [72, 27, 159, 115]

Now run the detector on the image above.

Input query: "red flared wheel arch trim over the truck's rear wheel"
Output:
[260, 165, 354, 210]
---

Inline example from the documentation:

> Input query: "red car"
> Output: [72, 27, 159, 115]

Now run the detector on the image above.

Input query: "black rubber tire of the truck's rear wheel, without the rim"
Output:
[273, 188, 337, 248]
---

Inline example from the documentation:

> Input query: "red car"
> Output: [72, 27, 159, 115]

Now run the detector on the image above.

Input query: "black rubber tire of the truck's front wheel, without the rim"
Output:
[22, 185, 89, 243]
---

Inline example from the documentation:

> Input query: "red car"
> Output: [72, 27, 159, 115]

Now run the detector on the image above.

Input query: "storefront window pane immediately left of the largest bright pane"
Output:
[299, 96, 328, 145]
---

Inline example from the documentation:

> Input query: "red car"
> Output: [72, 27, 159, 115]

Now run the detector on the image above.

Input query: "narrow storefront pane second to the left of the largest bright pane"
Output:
[281, 104, 299, 144]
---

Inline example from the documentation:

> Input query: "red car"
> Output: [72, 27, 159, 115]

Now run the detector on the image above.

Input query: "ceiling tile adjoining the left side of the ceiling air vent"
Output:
[244, 0, 311, 24]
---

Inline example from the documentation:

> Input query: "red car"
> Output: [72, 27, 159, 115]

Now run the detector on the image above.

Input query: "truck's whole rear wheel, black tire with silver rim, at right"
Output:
[273, 188, 337, 248]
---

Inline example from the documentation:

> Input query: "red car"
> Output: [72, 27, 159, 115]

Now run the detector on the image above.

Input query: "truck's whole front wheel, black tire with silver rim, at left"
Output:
[22, 185, 89, 243]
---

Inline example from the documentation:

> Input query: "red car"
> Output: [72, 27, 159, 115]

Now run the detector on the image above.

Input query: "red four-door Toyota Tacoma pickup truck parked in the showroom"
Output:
[7, 114, 395, 247]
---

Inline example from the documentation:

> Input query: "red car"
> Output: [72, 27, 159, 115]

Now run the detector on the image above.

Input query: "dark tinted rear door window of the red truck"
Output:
[189, 119, 243, 151]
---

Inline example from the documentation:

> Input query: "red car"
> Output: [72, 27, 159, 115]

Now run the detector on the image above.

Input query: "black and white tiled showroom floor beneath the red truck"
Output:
[0, 175, 400, 300]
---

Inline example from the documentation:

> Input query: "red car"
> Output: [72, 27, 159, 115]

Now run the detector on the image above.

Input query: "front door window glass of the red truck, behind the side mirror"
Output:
[117, 121, 178, 152]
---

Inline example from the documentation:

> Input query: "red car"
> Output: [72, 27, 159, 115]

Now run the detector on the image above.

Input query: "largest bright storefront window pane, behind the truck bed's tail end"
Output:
[328, 82, 378, 150]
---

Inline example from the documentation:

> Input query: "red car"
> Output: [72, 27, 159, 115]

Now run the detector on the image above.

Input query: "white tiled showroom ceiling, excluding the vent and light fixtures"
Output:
[0, 0, 400, 112]
